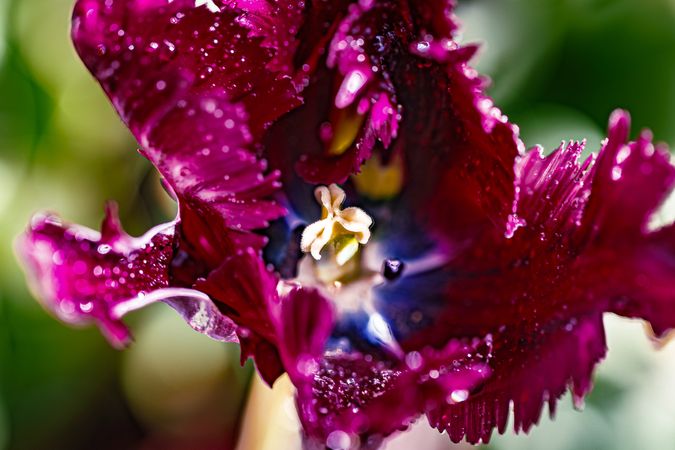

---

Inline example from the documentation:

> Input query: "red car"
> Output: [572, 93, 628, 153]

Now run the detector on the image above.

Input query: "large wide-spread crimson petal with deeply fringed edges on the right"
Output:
[425, 112, 675, 442]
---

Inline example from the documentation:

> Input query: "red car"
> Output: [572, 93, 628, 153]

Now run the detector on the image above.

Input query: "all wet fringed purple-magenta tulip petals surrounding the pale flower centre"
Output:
[19, 0, 675, 448]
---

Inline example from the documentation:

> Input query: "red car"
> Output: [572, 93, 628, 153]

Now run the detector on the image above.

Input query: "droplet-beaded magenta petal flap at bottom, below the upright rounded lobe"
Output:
[298, 339, 491, 444]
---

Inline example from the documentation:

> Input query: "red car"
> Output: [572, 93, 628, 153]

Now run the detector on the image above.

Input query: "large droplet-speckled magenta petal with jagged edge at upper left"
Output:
[73, 0, 298, 260]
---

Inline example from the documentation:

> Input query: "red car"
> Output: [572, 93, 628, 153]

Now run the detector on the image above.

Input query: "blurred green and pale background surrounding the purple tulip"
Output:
[0, 0, 675, 450]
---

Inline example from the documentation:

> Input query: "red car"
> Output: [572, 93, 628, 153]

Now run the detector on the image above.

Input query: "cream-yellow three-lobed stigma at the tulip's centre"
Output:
[300, 184, 373, 266]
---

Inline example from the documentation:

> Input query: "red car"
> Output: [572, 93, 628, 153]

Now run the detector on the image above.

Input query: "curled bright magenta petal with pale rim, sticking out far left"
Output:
[18, 204, 237, 347]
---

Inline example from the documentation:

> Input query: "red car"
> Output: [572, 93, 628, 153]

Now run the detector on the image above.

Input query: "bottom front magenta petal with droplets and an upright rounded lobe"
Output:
[273, 288, 491, 442]
